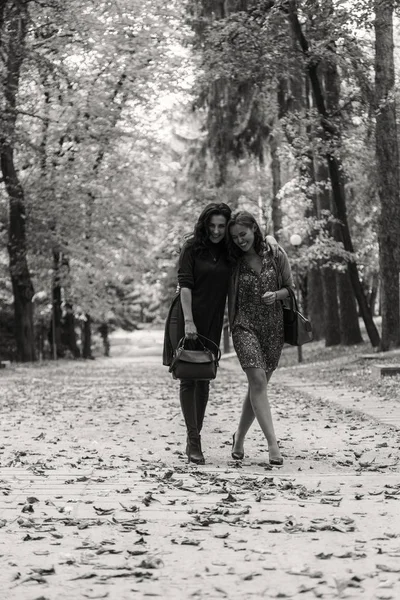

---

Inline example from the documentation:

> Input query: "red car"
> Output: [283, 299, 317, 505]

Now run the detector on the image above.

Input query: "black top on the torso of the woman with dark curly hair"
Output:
[178, 240, 231, 346]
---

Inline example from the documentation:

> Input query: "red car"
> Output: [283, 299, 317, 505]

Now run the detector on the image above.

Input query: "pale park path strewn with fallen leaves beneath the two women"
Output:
[0, 332, 400, 600]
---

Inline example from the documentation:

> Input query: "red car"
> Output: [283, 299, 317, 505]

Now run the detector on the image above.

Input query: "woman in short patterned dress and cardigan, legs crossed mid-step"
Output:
[227, 211, 293, 465]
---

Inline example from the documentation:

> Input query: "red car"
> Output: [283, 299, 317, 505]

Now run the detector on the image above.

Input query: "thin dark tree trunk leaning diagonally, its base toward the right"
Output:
[288, 0, 380, 347]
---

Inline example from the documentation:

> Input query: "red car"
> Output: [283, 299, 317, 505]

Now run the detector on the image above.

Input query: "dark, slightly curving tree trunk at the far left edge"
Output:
[0, 3, 36, 361]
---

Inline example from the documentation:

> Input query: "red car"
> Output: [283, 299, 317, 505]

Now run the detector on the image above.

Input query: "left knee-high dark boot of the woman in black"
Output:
[179, 379, 204, 464]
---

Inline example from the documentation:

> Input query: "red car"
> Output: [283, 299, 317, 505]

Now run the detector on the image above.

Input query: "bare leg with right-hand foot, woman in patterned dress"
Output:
[246, 368, 281, 459]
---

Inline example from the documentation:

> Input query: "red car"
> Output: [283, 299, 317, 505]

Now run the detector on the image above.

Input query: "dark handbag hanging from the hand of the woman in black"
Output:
[169, 333, 221, 381]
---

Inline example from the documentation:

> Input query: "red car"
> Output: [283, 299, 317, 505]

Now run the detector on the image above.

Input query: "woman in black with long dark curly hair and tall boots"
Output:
[163, 202, 276, 464]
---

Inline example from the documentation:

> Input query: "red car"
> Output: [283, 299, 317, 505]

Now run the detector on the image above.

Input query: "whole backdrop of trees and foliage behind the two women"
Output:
[0, 0, 400, 360]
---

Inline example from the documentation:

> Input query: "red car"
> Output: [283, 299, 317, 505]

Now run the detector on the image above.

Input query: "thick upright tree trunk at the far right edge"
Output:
[375, 0, 400, 351]
